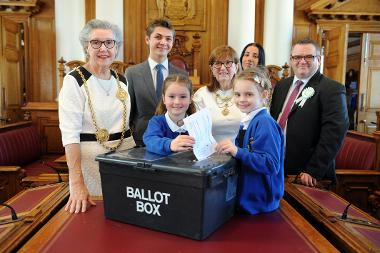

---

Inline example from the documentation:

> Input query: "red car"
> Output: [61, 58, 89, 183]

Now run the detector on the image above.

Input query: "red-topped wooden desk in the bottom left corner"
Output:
[0, 183, 69, 252]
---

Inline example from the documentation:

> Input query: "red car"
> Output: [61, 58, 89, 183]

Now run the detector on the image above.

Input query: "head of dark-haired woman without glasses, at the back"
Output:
[240, 43, 265, 70]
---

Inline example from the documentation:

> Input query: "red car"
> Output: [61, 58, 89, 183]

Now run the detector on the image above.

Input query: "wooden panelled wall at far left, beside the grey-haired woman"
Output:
[0, 0, 58, 153]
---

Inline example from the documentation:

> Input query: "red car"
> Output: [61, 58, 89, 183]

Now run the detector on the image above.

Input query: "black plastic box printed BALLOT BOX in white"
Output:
[96, 148, 237, 240]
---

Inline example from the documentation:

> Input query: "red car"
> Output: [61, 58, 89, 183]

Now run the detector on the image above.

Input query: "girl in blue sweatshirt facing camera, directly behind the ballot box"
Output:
[143, 74, 195, 155]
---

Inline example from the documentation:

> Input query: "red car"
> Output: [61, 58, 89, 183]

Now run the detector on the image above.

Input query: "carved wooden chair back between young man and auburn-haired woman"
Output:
[169, 31, 201, 90]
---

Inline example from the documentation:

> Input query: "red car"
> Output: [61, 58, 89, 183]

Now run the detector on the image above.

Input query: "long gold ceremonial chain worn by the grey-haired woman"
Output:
[75, 67, 128, 151]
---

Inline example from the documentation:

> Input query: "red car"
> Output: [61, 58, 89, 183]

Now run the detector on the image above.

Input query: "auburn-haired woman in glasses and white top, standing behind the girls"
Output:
[193, 46, 243, 141]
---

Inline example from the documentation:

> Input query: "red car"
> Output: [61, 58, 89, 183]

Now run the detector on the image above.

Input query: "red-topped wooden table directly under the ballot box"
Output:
[19, 200, 337, 253]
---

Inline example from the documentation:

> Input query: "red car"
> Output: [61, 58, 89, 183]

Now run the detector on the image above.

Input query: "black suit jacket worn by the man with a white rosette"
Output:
[270, 71, 349, 182]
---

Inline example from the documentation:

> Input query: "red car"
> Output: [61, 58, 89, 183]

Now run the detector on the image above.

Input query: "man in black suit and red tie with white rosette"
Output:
[270, 39, 349, 186]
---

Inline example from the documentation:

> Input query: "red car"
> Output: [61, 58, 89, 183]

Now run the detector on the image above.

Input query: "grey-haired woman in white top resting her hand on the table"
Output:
[59, 19, 135, 213]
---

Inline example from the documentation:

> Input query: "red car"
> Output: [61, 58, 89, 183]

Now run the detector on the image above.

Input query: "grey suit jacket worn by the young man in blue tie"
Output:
[125, 61, 187, 145]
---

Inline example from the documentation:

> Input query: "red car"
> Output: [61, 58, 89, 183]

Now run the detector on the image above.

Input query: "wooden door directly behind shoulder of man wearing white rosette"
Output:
[323, 24, 348, 84]
